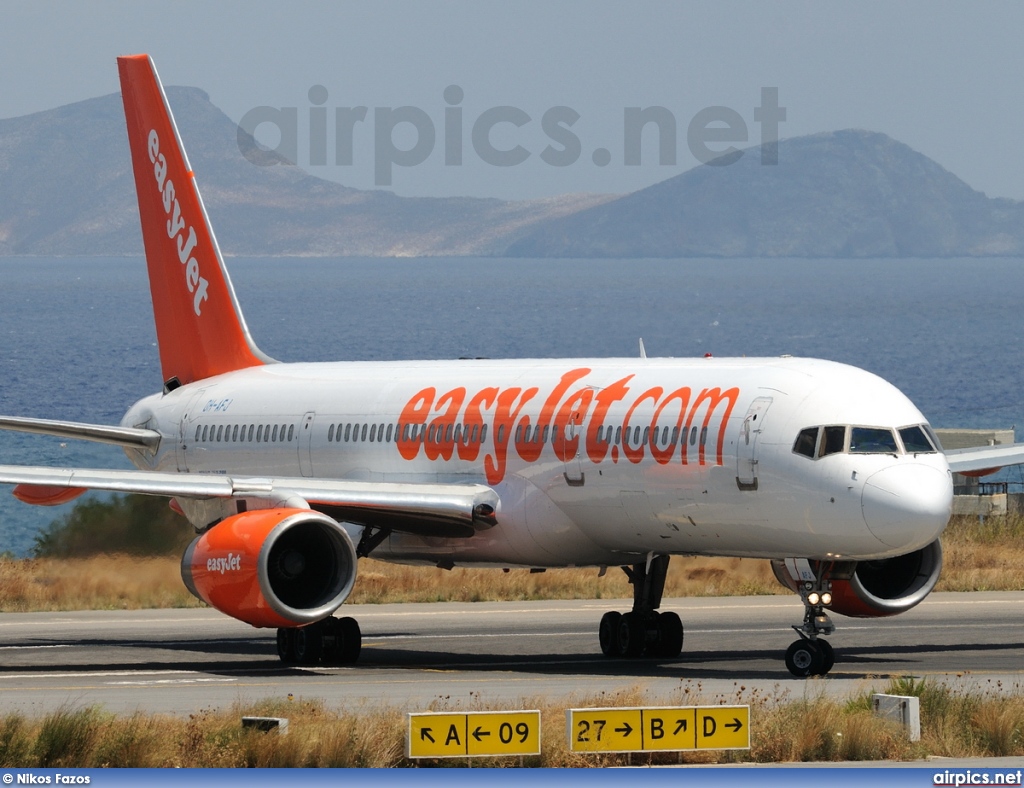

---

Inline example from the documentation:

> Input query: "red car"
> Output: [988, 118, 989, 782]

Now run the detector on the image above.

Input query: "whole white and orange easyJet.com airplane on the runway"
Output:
[0, 55, 1024, 675]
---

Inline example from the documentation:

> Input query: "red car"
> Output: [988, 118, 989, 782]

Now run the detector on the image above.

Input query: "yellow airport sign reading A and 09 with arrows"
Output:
[408, 710, 541, 758]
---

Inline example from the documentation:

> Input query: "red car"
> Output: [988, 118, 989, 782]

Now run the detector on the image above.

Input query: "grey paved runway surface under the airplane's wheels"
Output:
[0, 593, 1024, 715]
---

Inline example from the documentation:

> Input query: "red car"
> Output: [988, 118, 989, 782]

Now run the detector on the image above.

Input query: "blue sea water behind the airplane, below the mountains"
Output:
[0, 257, 1024, 556]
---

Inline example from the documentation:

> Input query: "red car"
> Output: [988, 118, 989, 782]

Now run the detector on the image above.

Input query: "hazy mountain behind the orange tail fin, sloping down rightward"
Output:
[0, 87, 608, 256]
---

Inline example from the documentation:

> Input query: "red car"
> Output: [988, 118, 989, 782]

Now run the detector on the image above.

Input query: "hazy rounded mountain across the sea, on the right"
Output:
[506, 130, 1024, 258]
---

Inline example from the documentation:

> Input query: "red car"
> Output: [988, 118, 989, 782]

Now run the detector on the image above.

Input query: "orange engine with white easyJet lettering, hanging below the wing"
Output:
[181, 509, 356, 626]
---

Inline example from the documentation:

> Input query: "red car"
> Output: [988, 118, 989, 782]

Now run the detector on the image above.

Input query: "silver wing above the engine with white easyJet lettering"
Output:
[0, 466, 499, 536]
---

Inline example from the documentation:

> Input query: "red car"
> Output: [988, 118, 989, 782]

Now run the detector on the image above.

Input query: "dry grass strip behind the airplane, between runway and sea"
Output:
[6, 516, 1024, 612]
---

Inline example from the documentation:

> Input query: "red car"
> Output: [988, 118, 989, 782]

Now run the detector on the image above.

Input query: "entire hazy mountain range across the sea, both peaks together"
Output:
[0, 88, 1024, 258]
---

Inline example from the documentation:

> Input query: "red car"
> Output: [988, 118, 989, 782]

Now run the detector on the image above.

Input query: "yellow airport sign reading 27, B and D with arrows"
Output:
[565, 706, 751, 752]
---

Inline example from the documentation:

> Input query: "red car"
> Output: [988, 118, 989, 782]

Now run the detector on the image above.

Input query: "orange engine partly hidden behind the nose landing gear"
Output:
[771, 539, 942, 618]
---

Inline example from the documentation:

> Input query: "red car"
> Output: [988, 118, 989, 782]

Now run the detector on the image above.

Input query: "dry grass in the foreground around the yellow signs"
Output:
[0, 680, 1024, 768]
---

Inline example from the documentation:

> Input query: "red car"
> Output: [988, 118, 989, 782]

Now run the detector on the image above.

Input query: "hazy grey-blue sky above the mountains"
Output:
[0, 0, 1024, 200]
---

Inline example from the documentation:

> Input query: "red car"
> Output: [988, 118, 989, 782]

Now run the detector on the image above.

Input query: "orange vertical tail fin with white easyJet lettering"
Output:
[118, 54, 272, 388]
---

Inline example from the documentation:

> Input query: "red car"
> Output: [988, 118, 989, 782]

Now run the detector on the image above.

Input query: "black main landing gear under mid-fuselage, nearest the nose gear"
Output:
[598, 556, 683, 659]
